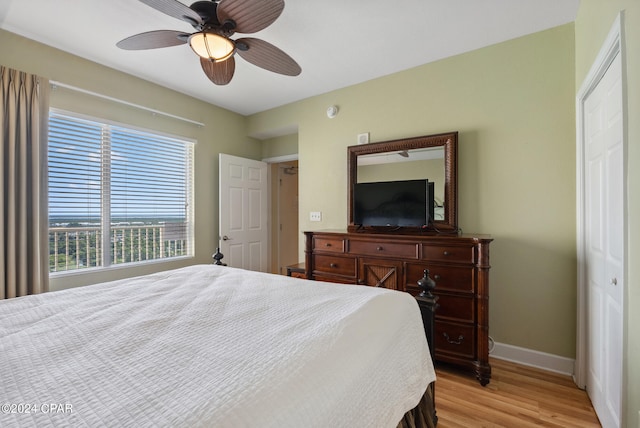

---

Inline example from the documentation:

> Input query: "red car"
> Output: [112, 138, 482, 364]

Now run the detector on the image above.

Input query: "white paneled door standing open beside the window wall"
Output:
[219, 153, 269, 272]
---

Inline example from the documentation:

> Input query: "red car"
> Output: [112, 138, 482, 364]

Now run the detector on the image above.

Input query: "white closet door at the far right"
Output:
[583, 54, 625, 428]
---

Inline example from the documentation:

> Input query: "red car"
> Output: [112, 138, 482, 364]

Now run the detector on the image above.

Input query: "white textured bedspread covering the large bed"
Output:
[0, 265, 435, 428]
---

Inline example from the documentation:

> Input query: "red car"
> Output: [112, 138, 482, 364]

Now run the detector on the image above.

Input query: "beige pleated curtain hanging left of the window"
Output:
[0, 66, 49, 299]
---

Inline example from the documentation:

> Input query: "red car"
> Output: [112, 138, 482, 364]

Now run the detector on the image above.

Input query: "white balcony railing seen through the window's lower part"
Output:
[49, 223, 188, 272]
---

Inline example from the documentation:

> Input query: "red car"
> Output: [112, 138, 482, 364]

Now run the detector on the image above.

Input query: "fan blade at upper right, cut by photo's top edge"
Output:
[217, 0, 284, 33]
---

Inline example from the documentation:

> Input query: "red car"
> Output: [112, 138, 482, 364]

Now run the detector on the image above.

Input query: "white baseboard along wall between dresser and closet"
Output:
[491, 342, 575, 376]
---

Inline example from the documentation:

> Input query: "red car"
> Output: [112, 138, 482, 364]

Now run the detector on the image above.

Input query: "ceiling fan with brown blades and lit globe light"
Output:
[116, 0, 302, 85]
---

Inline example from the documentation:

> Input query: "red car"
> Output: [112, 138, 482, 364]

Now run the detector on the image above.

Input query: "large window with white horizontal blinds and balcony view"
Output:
[48, 110, 194, 272]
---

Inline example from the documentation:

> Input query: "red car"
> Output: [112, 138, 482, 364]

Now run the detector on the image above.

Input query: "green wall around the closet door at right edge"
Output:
[575, 0, 640, 427]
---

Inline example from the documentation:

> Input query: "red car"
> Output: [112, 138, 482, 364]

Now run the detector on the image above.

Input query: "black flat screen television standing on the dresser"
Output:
[353, 179, 434, 227]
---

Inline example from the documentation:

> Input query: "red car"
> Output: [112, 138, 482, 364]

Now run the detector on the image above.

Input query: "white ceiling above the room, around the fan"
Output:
[0, 0, 579, 115]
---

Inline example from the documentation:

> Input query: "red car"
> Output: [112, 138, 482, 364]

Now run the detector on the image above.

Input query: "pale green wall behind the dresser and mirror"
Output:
[248, 24, 576, 358]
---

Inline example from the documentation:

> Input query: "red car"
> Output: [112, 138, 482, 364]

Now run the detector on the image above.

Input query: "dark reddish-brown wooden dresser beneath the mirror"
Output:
[305, 231, 492, 385]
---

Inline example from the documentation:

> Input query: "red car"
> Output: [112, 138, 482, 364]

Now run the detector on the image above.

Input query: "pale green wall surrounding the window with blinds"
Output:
[0, 30, 262, 290]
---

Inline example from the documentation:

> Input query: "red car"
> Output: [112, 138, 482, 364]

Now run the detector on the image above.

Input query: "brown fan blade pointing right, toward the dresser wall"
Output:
[236, 37, 302, 76]
